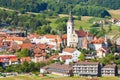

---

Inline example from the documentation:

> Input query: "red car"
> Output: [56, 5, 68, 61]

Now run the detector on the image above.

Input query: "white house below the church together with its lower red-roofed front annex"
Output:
[59, 48, 81, 63]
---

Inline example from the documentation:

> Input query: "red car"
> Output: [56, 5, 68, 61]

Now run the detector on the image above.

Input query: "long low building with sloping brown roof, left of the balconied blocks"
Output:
[40, 63, 73, 76]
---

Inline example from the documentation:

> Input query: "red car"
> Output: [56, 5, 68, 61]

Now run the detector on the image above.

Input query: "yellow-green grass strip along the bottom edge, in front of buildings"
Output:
[0, 75, 120, 80]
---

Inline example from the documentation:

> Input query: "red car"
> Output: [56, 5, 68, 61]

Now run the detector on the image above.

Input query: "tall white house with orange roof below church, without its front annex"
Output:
[59, 47, 81, 62]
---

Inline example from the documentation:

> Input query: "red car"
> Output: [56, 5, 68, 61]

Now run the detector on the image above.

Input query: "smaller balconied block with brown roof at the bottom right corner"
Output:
[101, 64, 118, 76]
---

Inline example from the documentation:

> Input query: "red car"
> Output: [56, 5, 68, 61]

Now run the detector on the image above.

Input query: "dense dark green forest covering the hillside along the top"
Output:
[0, 0, 120, 17]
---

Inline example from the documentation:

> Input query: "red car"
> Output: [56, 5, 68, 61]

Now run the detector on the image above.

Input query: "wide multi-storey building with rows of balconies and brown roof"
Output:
[73, 61, 101, 76]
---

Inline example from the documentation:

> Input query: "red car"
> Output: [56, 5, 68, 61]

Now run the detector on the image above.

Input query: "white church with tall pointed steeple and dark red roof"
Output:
[67, 12, 93, 49]
